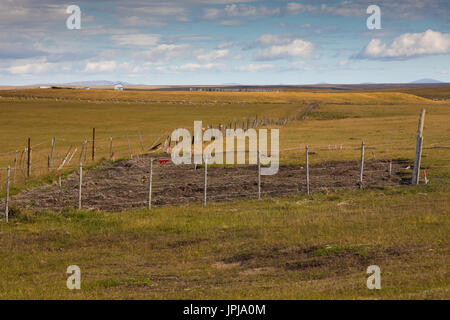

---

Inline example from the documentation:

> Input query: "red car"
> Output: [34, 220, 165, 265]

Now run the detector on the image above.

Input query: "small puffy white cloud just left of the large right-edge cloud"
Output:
[253, 39, 314, 60]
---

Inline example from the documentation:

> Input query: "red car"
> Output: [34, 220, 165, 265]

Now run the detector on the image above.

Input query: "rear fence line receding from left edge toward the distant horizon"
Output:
[0, 109, 319, 192]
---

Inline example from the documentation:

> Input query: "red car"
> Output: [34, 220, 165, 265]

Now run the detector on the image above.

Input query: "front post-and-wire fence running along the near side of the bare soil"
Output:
[1, 137, 450, 217]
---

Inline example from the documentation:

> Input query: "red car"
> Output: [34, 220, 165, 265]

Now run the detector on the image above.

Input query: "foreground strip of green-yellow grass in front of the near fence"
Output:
[0, 185, 450, 299]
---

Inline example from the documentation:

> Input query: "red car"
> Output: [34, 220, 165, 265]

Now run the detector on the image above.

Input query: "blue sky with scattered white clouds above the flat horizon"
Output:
[0, 0, 450, 85]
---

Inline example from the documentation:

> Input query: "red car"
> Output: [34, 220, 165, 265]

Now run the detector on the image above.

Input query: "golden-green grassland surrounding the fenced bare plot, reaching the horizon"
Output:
[0, 89, 450, 299]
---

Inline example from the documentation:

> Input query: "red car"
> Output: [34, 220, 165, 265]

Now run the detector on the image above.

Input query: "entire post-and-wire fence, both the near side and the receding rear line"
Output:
[0, 106, 450, 220]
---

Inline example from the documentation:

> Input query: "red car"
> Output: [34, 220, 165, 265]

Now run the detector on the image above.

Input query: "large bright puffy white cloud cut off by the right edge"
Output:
[356, 30, 450, 60]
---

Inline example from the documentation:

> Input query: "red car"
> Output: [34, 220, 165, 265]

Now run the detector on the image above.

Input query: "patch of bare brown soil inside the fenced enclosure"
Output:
[0, 156, 405, 211]
